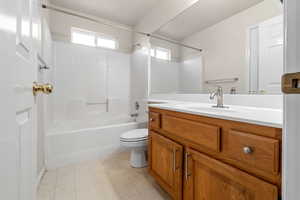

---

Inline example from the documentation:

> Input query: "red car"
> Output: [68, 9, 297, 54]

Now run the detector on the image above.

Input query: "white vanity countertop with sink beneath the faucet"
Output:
[149, 101, 283, 128]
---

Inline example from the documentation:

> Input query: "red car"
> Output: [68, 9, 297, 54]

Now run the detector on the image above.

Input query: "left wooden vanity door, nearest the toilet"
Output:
[149, 132, 183, 200]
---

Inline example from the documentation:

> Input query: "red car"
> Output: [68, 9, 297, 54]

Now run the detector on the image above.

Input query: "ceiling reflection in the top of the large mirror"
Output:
[157, 0, 263, 41]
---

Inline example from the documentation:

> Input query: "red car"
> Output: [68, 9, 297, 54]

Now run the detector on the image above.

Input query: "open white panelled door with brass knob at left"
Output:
[0, 0, 36, 200]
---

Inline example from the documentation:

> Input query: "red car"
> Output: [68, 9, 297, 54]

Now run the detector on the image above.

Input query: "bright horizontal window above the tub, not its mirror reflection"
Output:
[71, 28, 117, 49]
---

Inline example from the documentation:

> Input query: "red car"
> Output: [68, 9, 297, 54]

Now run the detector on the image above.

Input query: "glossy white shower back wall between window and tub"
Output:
[54, 42, 130, 120]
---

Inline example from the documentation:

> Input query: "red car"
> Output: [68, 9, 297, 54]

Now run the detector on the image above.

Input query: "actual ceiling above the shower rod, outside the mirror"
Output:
[51, 0, 160, 26]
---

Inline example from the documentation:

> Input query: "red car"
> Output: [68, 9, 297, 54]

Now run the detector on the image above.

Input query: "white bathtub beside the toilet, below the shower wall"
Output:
[46, 115, 146, 169]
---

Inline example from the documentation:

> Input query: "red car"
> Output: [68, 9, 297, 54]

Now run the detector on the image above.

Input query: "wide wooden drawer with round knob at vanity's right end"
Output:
[224, 130, 280, 174]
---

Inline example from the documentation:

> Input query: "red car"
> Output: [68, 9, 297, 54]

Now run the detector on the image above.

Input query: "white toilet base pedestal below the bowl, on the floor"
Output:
[130, 147, 148, 168]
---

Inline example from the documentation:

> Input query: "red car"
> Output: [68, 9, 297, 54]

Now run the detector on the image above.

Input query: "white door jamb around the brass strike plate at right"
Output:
[282, 0, 300, 200]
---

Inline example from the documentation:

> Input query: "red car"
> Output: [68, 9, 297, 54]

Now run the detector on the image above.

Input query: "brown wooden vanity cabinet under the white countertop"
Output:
[148, 107, 282, 200]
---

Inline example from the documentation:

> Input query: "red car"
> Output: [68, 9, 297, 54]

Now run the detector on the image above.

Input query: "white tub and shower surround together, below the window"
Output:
[46, 42, 146, 168]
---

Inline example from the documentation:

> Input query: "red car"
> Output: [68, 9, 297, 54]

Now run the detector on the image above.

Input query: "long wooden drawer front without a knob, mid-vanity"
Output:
[162, 115, 220, 151]
